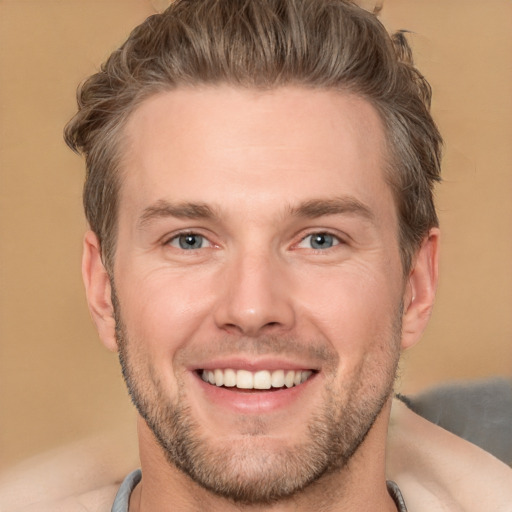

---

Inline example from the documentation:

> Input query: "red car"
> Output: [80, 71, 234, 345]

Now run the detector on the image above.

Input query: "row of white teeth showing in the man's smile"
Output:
[201, 368, 313, 389]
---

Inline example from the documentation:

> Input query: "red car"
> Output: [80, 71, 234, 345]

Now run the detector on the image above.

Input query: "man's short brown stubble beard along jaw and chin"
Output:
[116, 296, 401, 505]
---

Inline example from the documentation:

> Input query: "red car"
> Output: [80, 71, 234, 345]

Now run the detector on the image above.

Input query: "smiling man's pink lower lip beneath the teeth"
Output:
[194, 372, 317, 414]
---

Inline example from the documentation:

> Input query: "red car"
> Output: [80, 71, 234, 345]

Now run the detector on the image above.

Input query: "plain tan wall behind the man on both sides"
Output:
[0, 0, 512, 468]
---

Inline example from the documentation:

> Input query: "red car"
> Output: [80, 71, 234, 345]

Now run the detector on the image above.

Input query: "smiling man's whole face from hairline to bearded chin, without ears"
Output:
[109, 86, 404, 502]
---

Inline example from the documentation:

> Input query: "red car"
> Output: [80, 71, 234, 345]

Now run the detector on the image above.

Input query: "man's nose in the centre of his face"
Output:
[214, 249, 295, 337]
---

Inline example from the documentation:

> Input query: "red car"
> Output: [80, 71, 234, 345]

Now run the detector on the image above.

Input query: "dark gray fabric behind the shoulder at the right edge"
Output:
[405, 377, 512, 465]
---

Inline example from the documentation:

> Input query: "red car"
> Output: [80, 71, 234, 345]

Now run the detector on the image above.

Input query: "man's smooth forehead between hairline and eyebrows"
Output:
[120, 85, 392, 222]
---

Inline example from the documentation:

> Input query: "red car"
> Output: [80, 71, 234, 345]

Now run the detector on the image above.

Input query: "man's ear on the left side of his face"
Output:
[82, 231, 117, 352]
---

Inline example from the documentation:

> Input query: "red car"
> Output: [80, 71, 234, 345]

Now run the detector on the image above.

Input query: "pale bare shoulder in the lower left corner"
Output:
[0, 432, 140, 512]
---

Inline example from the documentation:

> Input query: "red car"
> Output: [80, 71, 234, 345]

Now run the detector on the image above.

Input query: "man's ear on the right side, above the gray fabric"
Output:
[402, 228, 440, 350]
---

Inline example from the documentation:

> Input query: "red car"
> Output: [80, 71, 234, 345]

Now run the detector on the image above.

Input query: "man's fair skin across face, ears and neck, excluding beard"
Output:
[83, 86, 439, 512]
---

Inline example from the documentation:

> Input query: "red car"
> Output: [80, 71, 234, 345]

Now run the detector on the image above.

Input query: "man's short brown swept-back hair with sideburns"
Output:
[65, 0, 442, 272]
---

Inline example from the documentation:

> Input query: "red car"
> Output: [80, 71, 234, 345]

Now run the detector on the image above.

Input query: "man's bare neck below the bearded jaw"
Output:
[130, 401, 396, 512]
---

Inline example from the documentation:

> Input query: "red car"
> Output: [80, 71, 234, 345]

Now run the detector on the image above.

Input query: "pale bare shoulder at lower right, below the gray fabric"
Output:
[387, 400, 512, 512]
